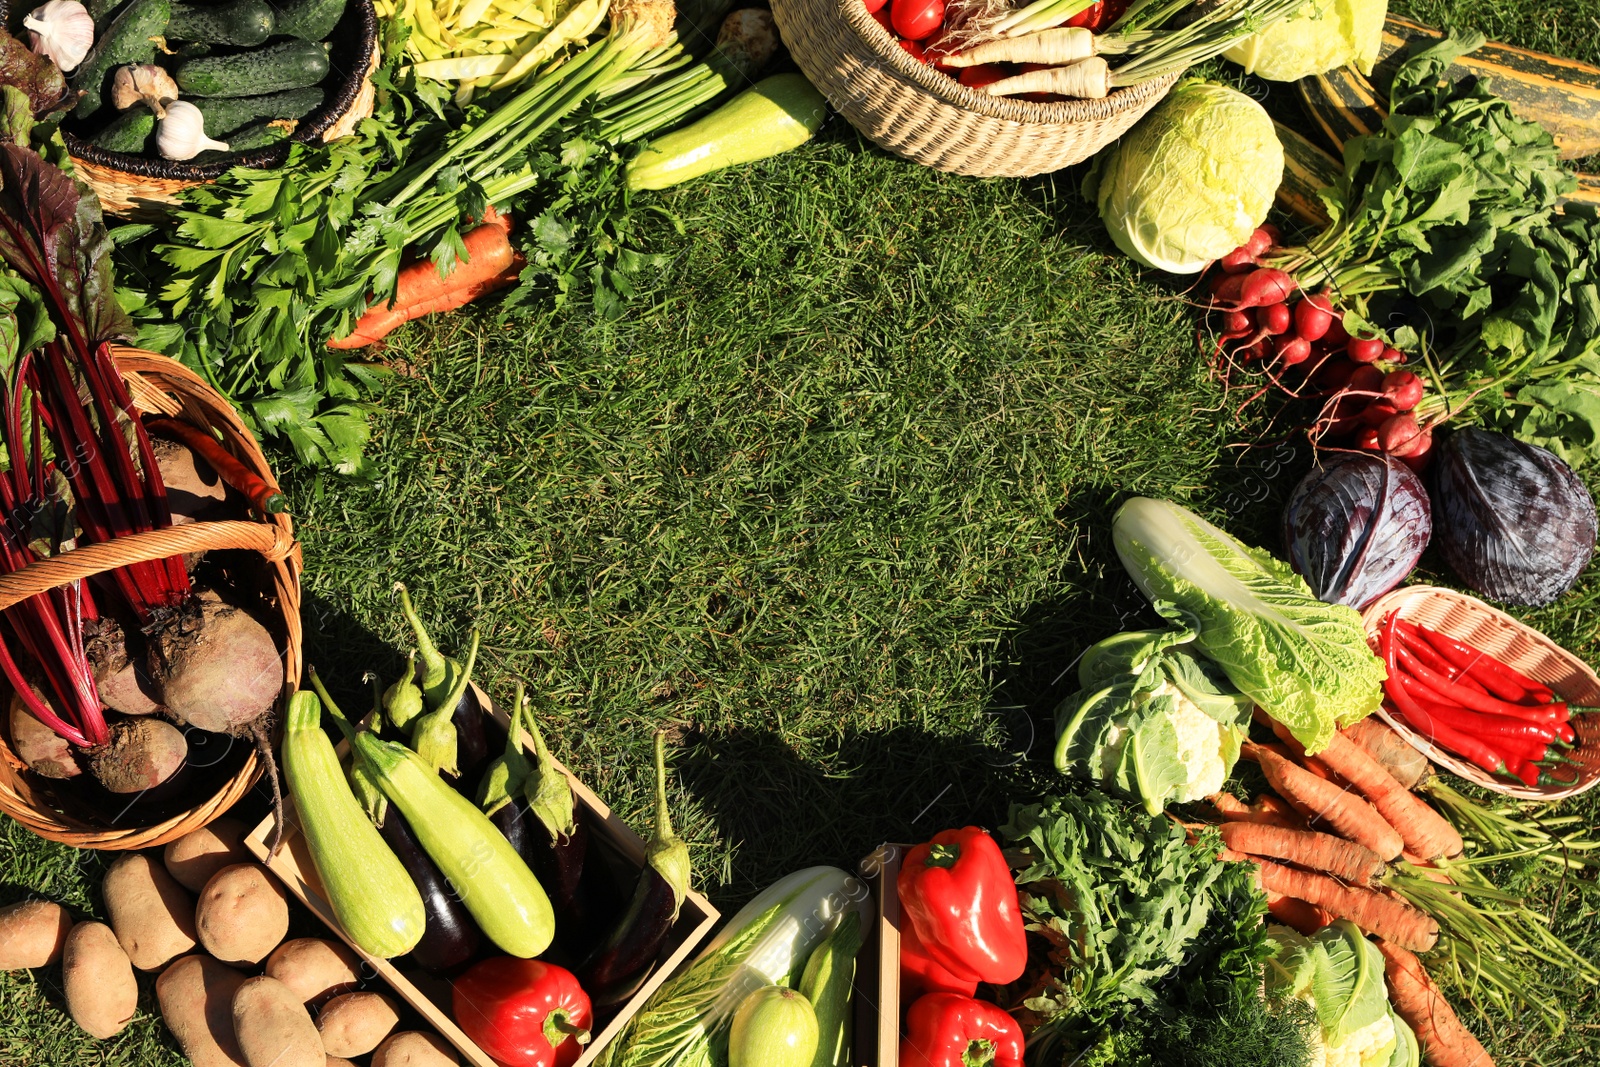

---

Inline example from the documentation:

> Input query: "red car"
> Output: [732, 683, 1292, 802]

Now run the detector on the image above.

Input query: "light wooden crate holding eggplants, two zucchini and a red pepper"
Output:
[245, 686, 722, 1067]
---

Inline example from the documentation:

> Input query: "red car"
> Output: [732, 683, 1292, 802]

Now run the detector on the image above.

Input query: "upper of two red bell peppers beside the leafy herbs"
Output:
[896, 825, 1027, 985]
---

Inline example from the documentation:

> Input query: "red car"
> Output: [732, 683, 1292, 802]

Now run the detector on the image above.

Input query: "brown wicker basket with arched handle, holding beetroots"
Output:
[0, 347, 301, 849]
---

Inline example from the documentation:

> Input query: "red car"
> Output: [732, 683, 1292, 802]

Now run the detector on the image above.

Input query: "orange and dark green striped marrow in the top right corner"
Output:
[1373, 14, 1600, 160]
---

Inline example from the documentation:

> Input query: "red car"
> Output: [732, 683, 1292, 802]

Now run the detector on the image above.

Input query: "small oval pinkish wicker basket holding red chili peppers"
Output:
[1362, 585, 1600, 800]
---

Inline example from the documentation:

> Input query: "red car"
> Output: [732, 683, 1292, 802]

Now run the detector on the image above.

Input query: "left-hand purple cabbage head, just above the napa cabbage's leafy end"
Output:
[1283, 453, 1434, 609]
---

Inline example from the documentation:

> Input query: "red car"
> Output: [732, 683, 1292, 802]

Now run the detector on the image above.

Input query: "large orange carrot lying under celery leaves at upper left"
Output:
[328, 208, 518, 350]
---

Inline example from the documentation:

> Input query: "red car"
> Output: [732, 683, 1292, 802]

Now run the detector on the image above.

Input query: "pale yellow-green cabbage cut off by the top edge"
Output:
[1222, 0, 1389, 82]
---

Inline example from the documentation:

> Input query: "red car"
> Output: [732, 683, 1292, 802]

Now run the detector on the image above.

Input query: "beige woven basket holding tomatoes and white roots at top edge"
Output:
[773, 0, 1179, 178]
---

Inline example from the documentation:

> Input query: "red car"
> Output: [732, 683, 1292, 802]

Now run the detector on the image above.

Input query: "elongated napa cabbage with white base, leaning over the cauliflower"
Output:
[1112, 496, 1384, 752]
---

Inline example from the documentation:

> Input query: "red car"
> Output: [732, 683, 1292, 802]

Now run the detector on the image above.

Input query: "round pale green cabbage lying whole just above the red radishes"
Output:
[1085, 80, 1283, 274]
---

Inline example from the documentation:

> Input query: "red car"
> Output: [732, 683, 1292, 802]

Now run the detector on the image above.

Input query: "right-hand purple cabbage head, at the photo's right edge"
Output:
[1430, 429, 1595, 608]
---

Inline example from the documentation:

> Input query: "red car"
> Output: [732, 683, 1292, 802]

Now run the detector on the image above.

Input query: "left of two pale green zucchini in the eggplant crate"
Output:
[283, 689, 425, 960]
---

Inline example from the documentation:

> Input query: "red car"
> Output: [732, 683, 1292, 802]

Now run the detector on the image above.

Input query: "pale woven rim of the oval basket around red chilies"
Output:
[1362, 585, 1600, 801]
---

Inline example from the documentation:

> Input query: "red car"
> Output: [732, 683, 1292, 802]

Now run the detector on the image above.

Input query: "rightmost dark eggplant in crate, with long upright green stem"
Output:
[576, 731, 690, 1009]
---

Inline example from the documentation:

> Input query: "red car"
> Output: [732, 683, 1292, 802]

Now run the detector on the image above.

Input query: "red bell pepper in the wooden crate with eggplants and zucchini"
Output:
[451, 957, 594, 1067]
